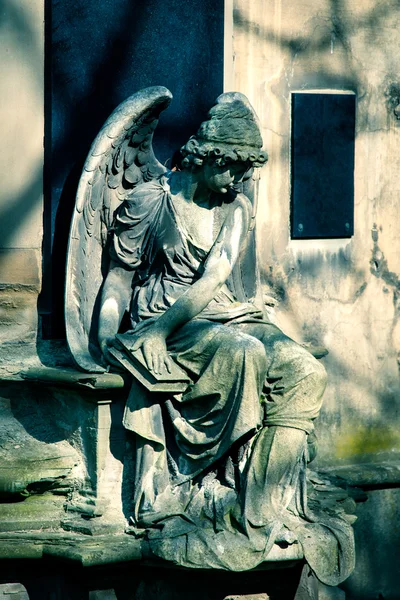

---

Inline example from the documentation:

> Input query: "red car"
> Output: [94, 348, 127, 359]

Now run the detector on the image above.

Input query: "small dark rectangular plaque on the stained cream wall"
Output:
[291, 93, 356, 239]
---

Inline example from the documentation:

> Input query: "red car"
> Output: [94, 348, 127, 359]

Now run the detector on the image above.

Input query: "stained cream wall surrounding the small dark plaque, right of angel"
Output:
[230, 0, 400, 464]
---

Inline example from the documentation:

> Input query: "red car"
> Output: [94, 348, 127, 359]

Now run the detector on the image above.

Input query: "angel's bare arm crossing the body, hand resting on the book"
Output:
[133, 195, 251, 372]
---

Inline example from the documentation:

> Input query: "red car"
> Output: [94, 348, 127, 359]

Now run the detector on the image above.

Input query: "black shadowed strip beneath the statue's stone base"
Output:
[0, 560, 304, 600]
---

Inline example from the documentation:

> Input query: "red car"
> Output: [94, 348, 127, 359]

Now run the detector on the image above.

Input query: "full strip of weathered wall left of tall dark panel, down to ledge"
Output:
[0, 0, 43, 362]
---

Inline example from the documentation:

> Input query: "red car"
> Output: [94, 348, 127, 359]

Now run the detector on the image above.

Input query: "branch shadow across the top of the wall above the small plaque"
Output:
[234, 0, 400, 136]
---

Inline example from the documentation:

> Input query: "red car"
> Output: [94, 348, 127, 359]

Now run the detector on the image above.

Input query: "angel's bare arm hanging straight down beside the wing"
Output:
[98, 261, 134, 355]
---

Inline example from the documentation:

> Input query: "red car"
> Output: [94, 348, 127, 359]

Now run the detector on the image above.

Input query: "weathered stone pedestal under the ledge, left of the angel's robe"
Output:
[0, 367, 127, 534]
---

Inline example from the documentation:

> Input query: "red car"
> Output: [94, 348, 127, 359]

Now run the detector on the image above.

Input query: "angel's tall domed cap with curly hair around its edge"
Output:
[181, 92, 268, 169]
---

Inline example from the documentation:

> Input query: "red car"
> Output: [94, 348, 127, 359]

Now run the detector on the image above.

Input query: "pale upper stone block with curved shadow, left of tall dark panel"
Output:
[0, 0, 44, 252]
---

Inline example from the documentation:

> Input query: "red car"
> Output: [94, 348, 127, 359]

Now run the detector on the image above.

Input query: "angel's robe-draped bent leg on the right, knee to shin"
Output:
[231, 324, 326, 541]
